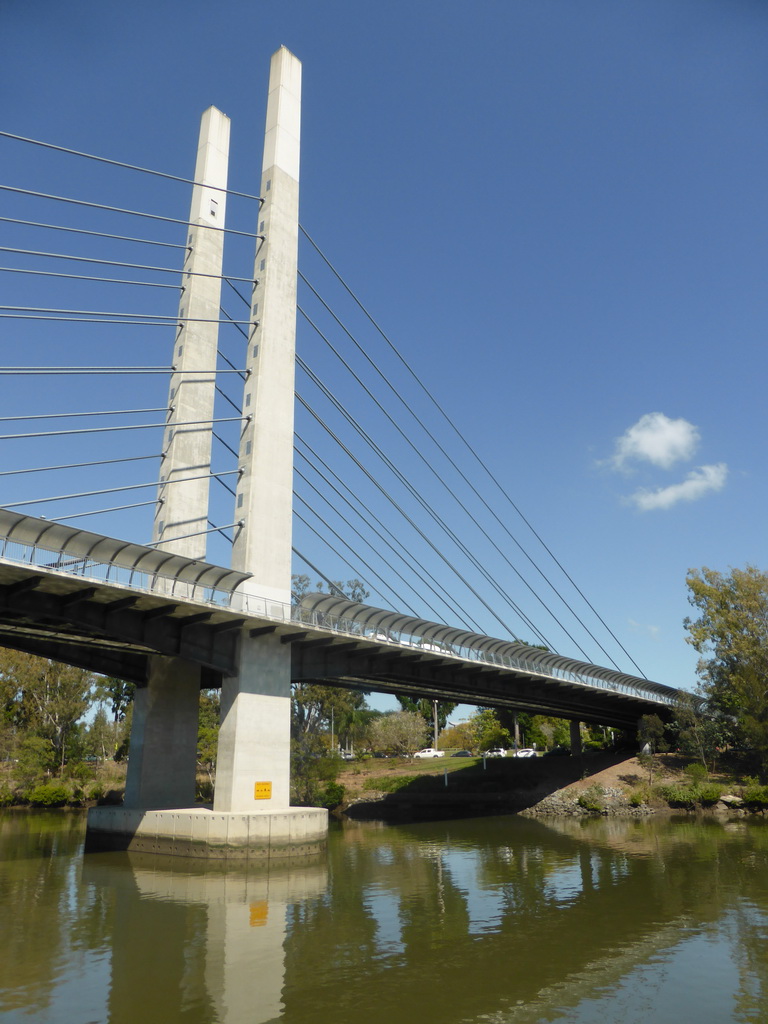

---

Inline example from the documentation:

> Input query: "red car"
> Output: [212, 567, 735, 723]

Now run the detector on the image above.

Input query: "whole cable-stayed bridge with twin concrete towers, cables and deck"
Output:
[0, 49, 677, 847]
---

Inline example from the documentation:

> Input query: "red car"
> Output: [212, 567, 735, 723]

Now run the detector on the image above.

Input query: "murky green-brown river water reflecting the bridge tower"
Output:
[0, 812, 768, 1024]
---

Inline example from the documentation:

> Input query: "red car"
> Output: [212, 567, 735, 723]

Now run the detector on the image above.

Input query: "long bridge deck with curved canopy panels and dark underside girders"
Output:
[0, 510, 680, 727]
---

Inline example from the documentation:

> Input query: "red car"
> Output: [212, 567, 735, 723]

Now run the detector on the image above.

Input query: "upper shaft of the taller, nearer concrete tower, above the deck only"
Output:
[232, 47, 301, 602]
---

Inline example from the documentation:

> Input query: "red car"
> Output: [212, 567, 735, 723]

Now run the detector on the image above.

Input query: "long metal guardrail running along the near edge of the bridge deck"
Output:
[0, 537, 676, 705]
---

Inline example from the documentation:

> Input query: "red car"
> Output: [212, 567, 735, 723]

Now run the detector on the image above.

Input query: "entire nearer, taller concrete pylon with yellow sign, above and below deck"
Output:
[214, 47, 301, 812]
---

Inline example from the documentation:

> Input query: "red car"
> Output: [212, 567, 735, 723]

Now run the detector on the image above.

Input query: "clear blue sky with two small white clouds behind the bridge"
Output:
[0, 0, 768, 708]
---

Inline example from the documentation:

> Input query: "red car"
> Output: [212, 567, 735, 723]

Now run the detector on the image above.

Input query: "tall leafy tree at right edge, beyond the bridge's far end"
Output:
[684, 565, 768, 772]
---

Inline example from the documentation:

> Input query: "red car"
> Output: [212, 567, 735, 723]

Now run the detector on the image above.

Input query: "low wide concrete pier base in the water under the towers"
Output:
[86, 807, 328, 861]
